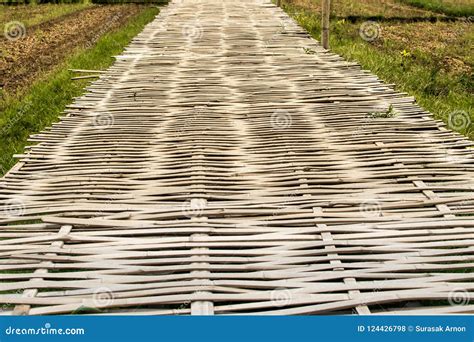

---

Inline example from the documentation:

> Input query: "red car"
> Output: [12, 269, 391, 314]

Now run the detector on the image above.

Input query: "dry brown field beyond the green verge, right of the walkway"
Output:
[285, 0, 474, 77]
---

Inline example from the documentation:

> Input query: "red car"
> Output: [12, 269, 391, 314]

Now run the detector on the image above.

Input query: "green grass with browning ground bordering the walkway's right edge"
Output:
[284, 3, 474, 139]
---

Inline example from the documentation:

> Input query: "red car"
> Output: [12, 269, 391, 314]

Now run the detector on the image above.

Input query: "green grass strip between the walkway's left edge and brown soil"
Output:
[0, 7, 159, 174]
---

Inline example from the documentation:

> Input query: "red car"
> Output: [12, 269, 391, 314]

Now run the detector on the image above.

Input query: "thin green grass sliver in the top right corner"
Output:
[399, 0, 474, 17]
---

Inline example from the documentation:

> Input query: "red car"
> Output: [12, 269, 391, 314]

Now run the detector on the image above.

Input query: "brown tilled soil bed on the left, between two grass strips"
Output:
[0, 5, 143, 94]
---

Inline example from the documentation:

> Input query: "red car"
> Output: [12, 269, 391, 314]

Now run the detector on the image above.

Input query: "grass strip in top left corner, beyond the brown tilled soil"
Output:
[0, 2, 92, 27]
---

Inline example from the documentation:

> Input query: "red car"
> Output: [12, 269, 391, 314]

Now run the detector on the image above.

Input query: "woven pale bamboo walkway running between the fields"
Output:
[0, 0, 474, 315]
